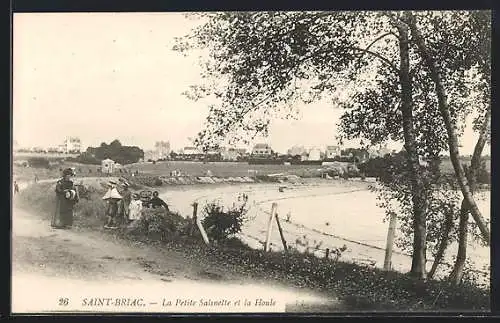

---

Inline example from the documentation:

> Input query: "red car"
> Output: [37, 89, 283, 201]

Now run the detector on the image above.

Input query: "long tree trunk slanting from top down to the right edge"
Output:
[407, 13, 490, 244]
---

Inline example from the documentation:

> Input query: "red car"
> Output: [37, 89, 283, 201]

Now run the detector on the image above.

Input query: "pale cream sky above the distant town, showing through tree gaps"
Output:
[13, 13, 490, 154]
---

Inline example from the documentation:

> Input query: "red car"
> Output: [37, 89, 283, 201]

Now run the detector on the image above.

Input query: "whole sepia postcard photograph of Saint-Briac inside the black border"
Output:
[11, 10, 492, 314]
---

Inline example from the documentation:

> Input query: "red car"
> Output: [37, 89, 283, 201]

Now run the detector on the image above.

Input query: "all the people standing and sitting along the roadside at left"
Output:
[51, 168, 169, 229]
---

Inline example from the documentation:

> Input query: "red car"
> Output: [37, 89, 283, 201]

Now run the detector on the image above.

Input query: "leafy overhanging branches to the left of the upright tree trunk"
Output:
[175, 12, 394, 149]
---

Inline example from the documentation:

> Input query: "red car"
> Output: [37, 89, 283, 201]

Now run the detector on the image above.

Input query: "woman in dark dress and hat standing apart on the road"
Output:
[51, 168, 78, 229]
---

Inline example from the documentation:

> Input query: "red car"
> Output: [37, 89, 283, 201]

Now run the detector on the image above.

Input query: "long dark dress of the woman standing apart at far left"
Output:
[52, 179, 78, 228]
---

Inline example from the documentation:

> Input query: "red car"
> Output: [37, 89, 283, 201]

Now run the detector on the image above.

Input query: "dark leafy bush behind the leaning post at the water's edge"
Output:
[201, 195, 248, 242]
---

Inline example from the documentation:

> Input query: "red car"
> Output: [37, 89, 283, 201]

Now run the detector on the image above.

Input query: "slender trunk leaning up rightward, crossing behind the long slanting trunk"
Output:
[449, 108, 491, 285]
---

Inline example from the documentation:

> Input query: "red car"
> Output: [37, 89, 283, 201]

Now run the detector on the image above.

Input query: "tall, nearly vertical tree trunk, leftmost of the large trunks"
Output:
[398, 20, 427, 278]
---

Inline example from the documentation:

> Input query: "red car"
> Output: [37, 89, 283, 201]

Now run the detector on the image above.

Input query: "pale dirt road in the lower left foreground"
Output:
[12, 202, 342, 313]
